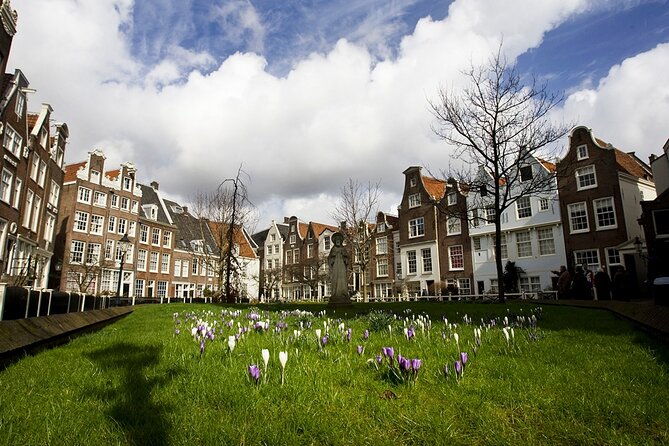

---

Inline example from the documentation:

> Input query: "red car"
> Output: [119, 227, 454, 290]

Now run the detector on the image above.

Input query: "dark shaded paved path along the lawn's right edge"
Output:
[541, 300, 669, 340]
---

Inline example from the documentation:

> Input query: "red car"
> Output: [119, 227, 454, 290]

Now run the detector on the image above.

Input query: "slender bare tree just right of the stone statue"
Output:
[331, 178, 381, 301]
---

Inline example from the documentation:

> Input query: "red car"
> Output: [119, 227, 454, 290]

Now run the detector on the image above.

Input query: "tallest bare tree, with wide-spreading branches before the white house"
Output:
[430, 47, 569, 302]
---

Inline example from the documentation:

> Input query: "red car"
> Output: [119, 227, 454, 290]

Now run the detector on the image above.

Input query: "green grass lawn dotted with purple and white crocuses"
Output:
[0, 303, 669, 445]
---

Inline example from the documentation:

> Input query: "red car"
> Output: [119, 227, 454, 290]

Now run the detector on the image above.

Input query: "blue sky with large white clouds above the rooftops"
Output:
[8, 0, 669, 231]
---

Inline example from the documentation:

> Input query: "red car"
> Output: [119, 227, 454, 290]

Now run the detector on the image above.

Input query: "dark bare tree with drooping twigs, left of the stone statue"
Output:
[191, 166, 255, 302]
